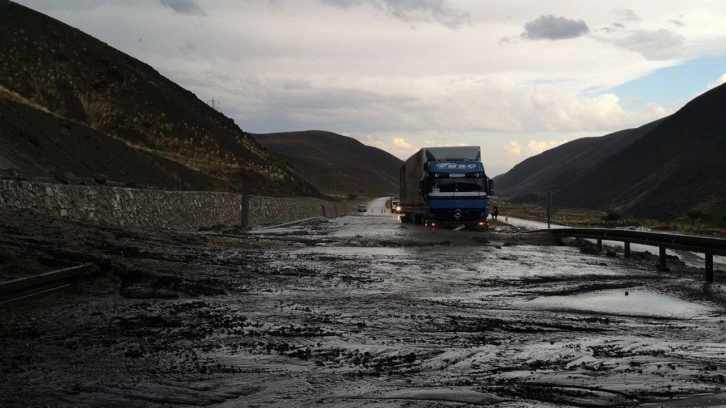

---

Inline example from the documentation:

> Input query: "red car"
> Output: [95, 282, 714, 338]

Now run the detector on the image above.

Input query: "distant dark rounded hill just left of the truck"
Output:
[253, 130, 402, 196]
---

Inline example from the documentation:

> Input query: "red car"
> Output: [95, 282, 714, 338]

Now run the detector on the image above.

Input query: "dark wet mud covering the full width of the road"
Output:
[0, 212, 726, 407]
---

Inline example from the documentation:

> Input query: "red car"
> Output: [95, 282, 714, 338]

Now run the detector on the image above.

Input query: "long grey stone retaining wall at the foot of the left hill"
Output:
[0, 180, 352, 231]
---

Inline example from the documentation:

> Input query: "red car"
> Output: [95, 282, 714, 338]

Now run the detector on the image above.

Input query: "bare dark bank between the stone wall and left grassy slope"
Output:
[0, 98, 221, 190]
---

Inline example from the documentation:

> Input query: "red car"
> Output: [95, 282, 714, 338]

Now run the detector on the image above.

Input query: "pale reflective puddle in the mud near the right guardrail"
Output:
[524, 289, 716, 319]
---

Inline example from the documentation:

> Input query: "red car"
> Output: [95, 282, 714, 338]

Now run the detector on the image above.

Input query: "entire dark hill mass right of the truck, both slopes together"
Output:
[496, 85, 726, 219]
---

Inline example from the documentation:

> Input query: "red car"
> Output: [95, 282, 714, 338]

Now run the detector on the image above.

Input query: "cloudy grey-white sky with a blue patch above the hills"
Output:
[18, 0, 726, 176]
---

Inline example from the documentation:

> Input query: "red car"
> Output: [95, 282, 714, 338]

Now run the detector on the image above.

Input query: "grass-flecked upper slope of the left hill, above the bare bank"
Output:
[0, 1, 320, 196]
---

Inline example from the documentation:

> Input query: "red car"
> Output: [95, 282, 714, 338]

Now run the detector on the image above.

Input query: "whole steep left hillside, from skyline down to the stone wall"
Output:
[0, 1, 320, 196]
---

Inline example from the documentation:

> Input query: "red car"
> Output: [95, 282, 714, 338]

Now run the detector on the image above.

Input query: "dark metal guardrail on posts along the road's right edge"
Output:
[540, 228, 726, 283]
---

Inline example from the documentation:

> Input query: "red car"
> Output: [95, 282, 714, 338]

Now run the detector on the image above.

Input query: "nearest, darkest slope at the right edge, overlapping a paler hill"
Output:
[558, 85, 726, 219]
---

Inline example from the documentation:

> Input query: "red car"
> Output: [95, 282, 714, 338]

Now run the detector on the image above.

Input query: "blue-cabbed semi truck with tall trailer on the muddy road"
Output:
[399, 146, 494, 229]
